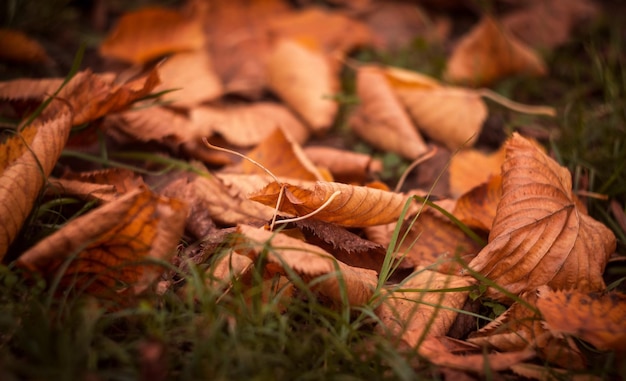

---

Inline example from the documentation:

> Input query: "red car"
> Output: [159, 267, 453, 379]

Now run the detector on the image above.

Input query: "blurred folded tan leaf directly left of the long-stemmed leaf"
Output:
[350, 66, 428, 159]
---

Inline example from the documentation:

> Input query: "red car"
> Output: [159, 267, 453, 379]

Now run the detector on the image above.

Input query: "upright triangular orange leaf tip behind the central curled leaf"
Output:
[235, 128, 326, 181]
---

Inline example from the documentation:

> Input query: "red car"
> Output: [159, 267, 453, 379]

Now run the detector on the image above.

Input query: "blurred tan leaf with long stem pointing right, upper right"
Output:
[385, 68, 487, 150]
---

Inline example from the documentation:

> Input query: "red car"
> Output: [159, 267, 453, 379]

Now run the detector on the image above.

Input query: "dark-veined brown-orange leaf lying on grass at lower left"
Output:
[18, 190, 187, 297]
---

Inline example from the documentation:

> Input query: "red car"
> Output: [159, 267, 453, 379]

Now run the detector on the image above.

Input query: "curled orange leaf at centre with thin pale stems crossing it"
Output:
[250, 181, 407, 227]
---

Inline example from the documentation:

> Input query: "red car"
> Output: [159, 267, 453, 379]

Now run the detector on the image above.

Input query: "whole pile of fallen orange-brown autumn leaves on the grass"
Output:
[0, 0, 626, 379]
